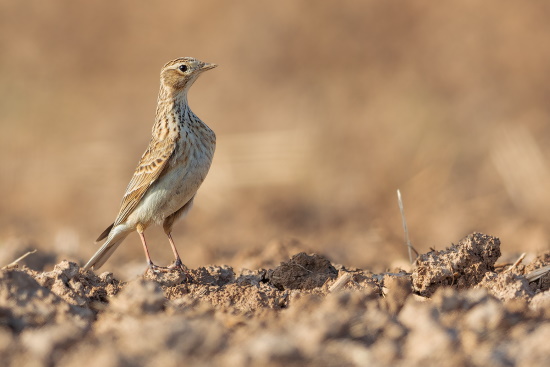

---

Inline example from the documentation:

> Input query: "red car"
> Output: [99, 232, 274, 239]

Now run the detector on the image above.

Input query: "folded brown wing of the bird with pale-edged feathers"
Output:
[114, 137, 176, 227]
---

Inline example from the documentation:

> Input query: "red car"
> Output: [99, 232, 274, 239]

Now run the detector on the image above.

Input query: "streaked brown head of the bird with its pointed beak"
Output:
[160, 57, 217, 93]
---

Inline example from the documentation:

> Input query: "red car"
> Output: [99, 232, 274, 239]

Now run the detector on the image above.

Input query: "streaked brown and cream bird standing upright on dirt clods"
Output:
[83, 57, 217, 272]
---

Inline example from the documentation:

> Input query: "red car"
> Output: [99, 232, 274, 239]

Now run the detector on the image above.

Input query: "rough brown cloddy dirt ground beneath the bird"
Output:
[0, 233, 550, 366]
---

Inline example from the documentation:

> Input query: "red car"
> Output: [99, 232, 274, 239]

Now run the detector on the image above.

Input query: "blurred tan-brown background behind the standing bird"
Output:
[0, 0, 550, 274]
